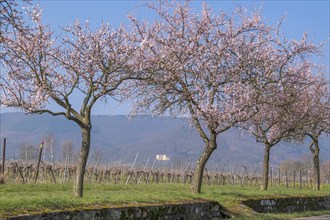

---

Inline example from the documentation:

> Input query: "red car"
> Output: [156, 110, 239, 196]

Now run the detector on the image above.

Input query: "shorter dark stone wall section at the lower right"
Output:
[242, 196, 330, 213]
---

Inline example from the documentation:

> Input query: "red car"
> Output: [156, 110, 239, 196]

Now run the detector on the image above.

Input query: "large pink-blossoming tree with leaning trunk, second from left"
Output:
[130, 1, 280, 193]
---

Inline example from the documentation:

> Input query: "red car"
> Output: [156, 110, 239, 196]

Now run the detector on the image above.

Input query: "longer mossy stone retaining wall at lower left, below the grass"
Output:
[8, 201, 230, 220]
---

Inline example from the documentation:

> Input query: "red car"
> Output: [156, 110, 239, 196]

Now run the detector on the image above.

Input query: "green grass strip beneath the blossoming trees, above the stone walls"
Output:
[0, 183, 330, 219]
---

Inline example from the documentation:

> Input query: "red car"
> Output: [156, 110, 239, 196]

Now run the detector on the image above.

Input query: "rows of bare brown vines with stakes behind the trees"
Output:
[0, 158, 329, 188]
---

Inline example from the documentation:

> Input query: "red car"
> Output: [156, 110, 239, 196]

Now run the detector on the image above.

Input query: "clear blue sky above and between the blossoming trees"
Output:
[1, 0, 330, 115]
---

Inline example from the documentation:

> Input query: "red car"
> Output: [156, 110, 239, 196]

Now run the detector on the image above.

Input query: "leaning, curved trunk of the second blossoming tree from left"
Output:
[191, 134, 217, 194]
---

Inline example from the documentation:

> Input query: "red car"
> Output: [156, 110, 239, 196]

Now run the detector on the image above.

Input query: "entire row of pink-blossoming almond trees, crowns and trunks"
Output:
[0, 0, 330, 197]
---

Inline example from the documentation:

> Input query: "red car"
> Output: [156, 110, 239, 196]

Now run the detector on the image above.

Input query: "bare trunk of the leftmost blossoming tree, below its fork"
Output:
[74, 126, 91, 198]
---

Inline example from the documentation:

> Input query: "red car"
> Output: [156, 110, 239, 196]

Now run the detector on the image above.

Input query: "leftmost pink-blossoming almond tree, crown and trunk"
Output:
[0, 1, 136, 197]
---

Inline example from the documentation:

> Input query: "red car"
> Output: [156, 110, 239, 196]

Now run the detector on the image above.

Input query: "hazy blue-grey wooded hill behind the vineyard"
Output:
[0, 113, 330, 171]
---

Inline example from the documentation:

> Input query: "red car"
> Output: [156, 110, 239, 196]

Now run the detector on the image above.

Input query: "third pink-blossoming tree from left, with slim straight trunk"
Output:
[240, 28, 321, 190]
